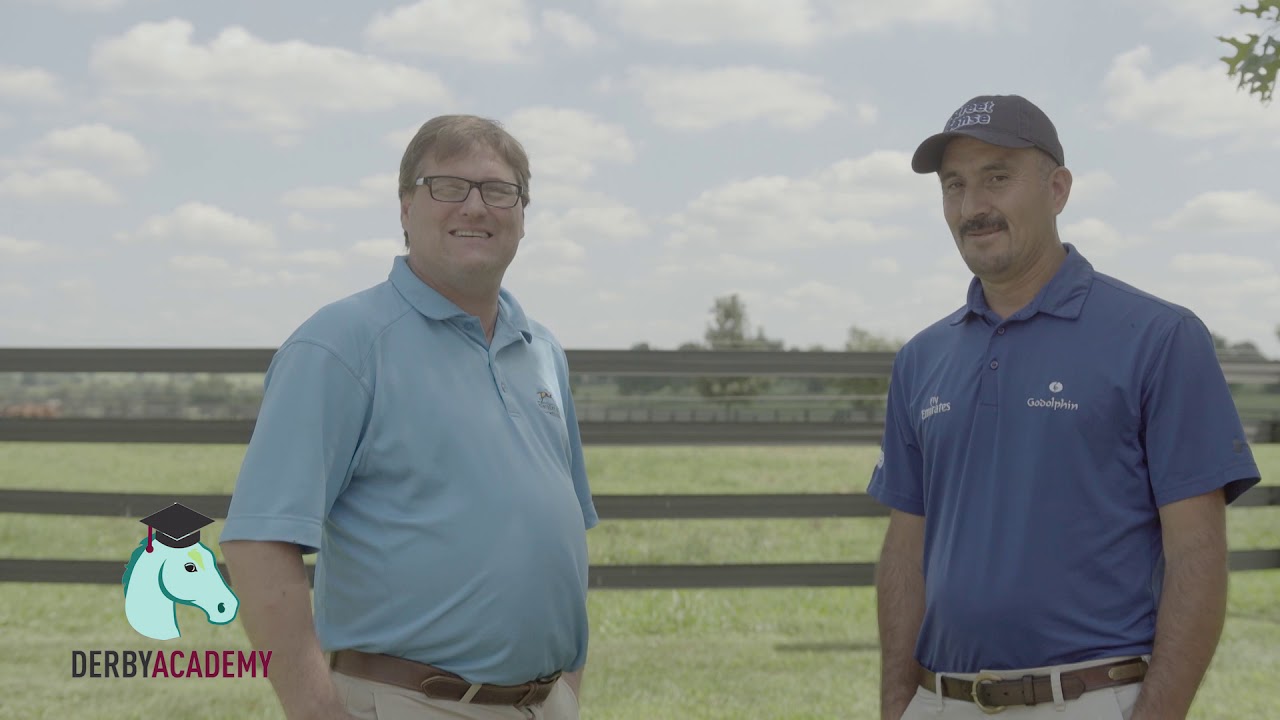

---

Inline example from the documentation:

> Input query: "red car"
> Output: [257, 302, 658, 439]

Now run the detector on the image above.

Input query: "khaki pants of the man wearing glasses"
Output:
[330, 673, 577, 720]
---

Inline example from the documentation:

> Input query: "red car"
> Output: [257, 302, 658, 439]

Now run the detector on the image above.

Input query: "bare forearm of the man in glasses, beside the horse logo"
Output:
[223, 541, 349, 720]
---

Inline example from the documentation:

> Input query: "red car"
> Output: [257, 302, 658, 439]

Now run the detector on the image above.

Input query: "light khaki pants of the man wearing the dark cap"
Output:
[902, 657, 1149, 720]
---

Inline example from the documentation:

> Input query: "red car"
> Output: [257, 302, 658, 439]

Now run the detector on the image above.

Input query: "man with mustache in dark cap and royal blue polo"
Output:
[868, 95, 1260, 720]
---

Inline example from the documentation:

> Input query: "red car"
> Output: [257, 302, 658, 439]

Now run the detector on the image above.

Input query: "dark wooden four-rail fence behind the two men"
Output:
[0, 348, 1280, 589]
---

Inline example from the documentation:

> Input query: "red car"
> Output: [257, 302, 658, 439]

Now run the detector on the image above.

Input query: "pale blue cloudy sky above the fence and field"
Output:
[0, 0, 1280, 356]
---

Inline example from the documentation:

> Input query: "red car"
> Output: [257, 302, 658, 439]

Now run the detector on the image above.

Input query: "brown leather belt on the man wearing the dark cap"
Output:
[920, 657, 1147, 714]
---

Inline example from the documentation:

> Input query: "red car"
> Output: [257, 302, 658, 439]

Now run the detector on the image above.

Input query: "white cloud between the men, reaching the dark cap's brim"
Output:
[667, 151, 934, 250]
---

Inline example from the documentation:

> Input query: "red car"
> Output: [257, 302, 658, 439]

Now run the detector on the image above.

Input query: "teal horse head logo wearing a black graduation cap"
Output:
[124, 502, 239, 641]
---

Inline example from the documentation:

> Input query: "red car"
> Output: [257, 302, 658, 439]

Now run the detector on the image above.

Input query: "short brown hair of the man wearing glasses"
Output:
[399, 115, 530, 205]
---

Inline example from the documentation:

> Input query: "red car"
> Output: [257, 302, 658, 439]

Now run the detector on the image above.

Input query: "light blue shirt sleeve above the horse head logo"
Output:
[220, 341, 371, 553]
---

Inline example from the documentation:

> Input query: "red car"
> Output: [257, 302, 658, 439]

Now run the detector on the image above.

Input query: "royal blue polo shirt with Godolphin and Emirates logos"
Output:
[868, 245, 1260, 673]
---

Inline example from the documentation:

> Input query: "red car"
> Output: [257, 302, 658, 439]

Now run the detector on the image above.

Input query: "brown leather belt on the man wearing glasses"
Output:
[329, 650, 559, 707]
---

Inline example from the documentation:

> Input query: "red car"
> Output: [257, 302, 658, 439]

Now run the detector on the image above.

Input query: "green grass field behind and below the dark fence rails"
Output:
[0, 443, 1280, 720]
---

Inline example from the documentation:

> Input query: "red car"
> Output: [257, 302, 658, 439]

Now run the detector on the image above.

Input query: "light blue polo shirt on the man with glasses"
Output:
[221, 256, 598, 684]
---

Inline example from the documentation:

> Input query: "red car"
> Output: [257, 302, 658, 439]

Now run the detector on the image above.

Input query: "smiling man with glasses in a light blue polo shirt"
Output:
[221, 115, 598, 720]
